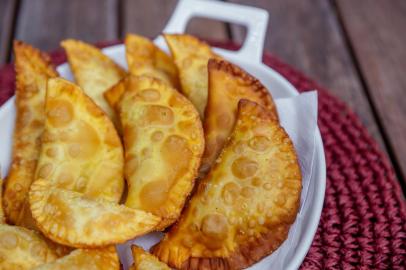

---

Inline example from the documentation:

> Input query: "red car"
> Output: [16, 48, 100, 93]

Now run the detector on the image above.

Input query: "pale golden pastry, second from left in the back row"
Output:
[61, 39, 126, 121]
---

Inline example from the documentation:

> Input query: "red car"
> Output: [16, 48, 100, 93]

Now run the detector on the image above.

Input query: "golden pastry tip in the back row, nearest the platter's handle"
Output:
[164, 34, 219, 118]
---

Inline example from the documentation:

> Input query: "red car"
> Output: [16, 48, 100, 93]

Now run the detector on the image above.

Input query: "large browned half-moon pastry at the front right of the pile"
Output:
[153, 99, 301, 269]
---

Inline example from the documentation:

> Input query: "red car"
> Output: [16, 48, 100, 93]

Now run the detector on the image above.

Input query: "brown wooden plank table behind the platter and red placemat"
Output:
[0, 0, 406, 194]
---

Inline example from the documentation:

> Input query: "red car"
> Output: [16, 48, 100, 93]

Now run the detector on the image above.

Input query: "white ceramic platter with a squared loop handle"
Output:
[0, 0, 326, 269]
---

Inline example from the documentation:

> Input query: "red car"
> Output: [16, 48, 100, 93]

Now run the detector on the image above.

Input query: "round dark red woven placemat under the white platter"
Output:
[0, 42, 406, 269]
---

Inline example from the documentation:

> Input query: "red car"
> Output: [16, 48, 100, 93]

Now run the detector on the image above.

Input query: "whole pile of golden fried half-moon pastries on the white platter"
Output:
[0, 34, 302, 270]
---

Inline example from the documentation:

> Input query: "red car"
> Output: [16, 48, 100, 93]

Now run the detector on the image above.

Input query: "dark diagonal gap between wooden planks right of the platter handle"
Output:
[329, 0, 406, 195]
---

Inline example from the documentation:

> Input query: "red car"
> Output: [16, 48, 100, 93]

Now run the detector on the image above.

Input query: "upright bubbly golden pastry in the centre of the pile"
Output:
[117, 76, 204, 229]
